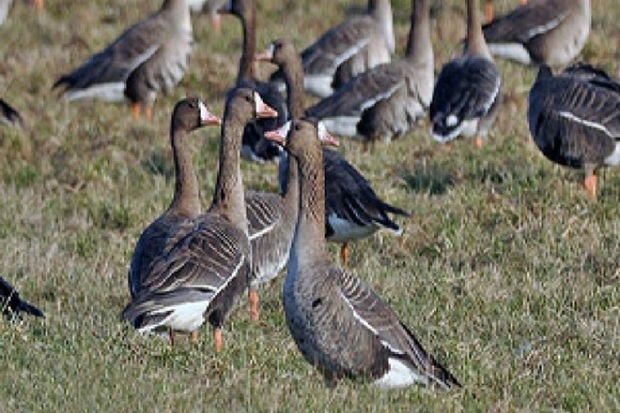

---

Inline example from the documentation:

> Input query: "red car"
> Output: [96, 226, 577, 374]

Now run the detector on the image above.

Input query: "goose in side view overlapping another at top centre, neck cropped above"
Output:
[307, 1, 434, 140]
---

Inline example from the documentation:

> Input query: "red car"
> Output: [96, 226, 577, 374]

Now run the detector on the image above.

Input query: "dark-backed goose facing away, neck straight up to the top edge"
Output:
[430, 0, 501, 147]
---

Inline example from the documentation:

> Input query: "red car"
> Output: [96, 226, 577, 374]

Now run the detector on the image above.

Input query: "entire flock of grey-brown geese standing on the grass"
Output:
[0, 0, 620, 389]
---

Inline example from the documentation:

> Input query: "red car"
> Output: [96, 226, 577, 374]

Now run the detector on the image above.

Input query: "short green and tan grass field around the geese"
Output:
[0, 0, 620, 412]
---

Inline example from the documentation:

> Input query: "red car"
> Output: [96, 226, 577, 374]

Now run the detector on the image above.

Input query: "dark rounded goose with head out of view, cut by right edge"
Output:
[527, 64, 620, 198]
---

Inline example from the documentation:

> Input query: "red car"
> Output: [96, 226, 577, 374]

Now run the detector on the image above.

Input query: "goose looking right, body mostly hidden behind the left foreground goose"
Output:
[128, 98, 220, 298]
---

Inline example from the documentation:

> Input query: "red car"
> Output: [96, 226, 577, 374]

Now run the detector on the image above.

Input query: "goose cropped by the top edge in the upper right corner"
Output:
[483, 0, 591, 66]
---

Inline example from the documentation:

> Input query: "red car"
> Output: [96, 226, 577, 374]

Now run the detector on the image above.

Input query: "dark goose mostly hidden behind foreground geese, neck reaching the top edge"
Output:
[220, 0, 287, 162]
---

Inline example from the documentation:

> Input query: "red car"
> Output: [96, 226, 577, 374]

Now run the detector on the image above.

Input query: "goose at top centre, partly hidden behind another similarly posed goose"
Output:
[271, 0, 395, 98]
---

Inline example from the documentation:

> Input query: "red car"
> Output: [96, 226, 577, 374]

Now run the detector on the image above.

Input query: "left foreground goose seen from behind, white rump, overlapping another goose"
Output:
[123, 88, 277, 351]
